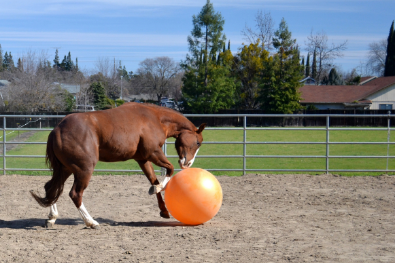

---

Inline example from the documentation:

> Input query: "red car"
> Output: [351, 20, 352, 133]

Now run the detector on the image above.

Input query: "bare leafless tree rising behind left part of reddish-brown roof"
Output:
[305, 30, 347, 81]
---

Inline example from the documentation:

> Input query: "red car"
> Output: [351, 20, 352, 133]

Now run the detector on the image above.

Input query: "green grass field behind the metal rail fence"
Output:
[0, 130, 395, 175]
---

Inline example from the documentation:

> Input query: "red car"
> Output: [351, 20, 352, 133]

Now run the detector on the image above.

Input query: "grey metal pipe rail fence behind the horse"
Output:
[0, 114, 395, 174]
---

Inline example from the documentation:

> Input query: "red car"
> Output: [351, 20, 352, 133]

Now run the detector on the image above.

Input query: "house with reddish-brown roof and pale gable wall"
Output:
[300, 76, 395, 110]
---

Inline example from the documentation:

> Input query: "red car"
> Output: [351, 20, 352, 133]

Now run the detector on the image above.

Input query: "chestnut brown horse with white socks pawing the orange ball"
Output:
[31, 103, 206, 228]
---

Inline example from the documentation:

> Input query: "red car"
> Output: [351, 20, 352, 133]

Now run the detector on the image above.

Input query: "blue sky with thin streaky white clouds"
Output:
[0, 0, 395, 74]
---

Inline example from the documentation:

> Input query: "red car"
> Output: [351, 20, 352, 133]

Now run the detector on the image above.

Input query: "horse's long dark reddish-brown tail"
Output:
[30, 131, 70, 207]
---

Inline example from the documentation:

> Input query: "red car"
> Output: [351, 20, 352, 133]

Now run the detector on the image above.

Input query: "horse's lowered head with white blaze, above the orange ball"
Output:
[176, 123, 206, 169]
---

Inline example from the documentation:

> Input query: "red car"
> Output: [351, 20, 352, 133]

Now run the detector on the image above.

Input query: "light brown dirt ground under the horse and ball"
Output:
[0, 174, 395, 262]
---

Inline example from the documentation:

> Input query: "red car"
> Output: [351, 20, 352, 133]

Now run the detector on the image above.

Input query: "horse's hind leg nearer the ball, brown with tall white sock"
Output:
[70, 173, 99, 229]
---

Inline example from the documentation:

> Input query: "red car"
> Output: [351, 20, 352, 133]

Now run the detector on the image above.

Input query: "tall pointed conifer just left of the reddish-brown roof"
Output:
[260, 18, 303, 113]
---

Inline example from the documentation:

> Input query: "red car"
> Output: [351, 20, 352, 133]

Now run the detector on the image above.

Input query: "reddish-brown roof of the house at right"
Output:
[300, 76, 395, 103]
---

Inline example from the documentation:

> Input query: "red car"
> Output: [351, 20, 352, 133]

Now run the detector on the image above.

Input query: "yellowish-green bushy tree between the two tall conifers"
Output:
[232, 40, 269, 109]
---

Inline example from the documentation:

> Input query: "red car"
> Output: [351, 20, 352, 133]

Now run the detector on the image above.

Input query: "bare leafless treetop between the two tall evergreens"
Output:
[241, 10, 274, 52]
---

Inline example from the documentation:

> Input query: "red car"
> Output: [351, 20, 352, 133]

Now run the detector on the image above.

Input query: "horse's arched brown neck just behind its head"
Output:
[161, 113, 196, 138]
